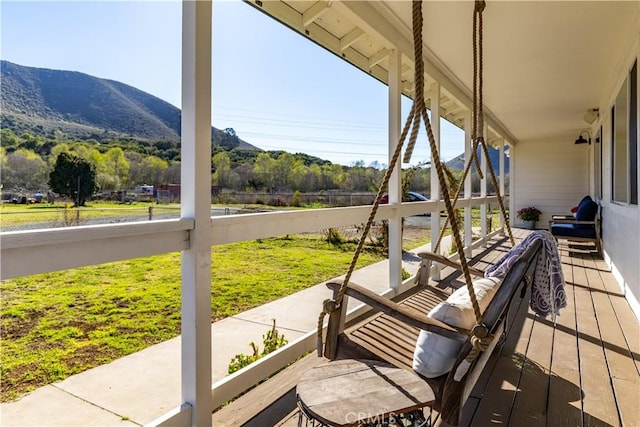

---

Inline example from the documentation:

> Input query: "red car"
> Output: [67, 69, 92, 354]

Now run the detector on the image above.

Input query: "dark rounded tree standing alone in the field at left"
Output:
[49, 153, 98, 206]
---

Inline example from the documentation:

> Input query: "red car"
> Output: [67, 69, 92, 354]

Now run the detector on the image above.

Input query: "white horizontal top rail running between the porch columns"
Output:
[0, 196, 497, 279]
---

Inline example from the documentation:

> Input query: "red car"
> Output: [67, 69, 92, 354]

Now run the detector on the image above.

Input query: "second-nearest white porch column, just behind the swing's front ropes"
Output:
[389, 49, 402, 290]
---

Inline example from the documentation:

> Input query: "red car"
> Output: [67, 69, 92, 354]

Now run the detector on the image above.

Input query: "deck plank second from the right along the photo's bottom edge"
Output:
[573, 252, 619, 425]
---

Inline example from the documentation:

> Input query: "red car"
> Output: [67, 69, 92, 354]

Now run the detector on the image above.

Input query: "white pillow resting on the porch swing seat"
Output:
[413, 277, 501, 378]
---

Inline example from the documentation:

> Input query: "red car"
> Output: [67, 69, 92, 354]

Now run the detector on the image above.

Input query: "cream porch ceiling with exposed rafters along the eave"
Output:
[251, 0, 640, 142]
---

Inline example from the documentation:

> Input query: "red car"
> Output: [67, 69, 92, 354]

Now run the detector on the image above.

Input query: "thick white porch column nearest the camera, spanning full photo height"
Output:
[180, 0, 212, 426]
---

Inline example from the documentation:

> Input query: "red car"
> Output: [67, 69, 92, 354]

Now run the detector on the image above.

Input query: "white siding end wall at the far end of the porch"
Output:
[510, 139, 589, 229]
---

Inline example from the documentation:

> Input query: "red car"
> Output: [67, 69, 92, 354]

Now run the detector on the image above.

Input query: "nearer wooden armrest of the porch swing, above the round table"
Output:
[327, 282, 469, 339]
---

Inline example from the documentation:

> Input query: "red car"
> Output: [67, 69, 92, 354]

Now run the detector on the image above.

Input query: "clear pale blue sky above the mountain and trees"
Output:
[0, 0, 463, 165]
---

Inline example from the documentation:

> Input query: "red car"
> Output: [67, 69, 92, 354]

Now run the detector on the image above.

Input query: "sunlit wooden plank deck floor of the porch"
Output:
[278, 230, 640, 427]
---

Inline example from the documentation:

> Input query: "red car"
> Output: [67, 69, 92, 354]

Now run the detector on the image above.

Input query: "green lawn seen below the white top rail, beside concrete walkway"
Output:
[0, 232, 383, 401]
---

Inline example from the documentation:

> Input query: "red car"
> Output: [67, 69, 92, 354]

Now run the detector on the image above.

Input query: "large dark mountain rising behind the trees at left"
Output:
[0, 61, 257, 149]
